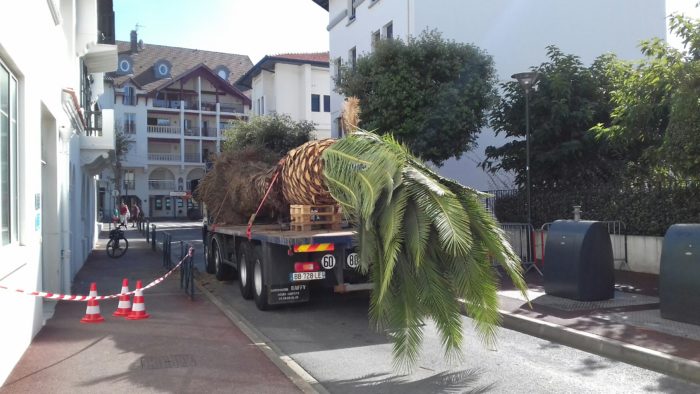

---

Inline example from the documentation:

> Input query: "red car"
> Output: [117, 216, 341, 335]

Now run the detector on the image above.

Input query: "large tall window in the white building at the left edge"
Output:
[0, 62, 19, 245]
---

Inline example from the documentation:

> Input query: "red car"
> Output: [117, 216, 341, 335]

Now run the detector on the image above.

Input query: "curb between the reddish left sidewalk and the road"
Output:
[194, 278, 329, 394]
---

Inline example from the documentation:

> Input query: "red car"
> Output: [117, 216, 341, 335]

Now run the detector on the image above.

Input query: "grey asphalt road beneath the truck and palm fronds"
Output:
[150, 223, 700, 394]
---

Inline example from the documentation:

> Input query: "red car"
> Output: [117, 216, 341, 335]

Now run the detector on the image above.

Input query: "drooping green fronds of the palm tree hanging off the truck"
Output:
[323, 130, 526, 369]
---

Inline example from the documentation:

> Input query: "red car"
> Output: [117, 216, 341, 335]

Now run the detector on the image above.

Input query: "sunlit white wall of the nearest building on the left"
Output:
[0, 0, 109, 384]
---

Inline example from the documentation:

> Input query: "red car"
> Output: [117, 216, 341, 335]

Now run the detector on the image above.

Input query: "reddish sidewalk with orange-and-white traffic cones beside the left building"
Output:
[0, 230, 302, 393]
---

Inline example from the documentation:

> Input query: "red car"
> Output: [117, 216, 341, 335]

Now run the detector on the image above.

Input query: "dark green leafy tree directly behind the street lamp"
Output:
[482, 46, 622, 189]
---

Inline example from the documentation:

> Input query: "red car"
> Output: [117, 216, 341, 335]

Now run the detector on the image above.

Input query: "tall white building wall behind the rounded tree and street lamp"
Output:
[329, 0, 666, 190]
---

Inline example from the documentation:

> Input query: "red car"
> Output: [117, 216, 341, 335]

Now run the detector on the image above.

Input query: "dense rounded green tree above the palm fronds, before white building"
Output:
[336, 31, 495, 166]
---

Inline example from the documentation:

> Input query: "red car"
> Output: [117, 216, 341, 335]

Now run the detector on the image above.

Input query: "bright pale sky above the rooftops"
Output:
[114, 0, 700, 63]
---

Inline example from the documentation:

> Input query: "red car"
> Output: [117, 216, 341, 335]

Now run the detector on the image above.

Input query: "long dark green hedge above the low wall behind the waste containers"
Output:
[494, 184, 700, 236]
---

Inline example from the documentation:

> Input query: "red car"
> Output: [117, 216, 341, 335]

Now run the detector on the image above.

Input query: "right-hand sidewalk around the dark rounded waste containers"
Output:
[499, 270, 700, 383]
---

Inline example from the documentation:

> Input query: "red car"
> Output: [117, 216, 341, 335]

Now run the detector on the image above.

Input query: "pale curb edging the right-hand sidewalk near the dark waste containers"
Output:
[499, 310, 700, 384]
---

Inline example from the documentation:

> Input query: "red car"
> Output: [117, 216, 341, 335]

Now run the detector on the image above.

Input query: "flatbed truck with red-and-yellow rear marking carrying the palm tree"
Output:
[202, 221, 372, 310]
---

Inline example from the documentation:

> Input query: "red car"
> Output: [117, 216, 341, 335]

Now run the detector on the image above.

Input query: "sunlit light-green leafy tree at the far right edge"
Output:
[595, 15, 700, 179]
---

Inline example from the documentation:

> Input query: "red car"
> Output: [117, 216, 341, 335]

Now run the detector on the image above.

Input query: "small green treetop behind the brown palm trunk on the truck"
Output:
[223, 114, 315, 158]
